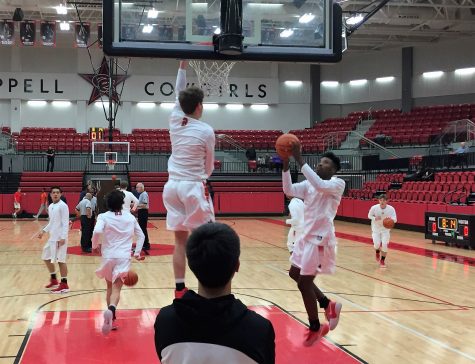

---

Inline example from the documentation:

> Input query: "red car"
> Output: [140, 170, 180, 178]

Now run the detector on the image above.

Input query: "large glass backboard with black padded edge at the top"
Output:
[103, 0, 342, 63]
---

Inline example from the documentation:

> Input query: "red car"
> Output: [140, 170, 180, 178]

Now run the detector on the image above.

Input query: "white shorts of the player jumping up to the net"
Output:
[163, 180, 214, 231]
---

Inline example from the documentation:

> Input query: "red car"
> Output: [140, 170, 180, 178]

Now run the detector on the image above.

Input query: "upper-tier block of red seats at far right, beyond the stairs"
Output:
[361, 104, 475, 146]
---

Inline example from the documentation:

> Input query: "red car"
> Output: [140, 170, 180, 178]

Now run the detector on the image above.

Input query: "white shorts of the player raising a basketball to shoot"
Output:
[290, 239, 336, 276]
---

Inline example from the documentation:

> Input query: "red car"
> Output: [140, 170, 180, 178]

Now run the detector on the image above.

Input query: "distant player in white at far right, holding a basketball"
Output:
[368, 194, 397, 268]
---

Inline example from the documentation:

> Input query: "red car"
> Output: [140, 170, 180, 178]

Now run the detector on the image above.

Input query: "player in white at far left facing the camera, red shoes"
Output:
[38, 186, 69, 293]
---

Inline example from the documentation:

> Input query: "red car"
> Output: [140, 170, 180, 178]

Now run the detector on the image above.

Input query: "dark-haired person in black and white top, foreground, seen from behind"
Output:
[155, 223, 275, 364]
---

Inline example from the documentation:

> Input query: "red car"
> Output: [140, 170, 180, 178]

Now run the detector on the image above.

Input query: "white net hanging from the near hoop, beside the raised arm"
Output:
[189, 60, 236, 96]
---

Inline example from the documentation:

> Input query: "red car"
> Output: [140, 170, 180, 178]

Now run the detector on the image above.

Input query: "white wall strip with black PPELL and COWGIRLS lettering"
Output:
[0, 72, 279, 104]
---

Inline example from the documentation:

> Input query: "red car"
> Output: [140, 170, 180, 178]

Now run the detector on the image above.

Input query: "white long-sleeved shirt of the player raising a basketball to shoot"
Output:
[282, 164, 345, 245]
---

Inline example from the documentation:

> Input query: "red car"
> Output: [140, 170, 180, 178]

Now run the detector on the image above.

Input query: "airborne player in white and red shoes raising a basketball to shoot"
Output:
[282, 143, 345, 346]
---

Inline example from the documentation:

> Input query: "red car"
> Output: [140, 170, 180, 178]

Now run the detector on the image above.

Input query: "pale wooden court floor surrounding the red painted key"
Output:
[0, 218, 475, 364]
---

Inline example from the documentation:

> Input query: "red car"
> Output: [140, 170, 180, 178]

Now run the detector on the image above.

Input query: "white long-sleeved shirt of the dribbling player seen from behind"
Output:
[92, 211, 145, 259]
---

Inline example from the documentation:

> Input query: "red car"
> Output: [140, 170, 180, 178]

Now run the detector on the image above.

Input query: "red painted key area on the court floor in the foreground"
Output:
[20, 306, 360, 364]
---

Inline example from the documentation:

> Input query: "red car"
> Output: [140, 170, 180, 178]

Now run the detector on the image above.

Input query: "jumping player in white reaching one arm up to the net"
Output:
[163, 61, 215, 298]
